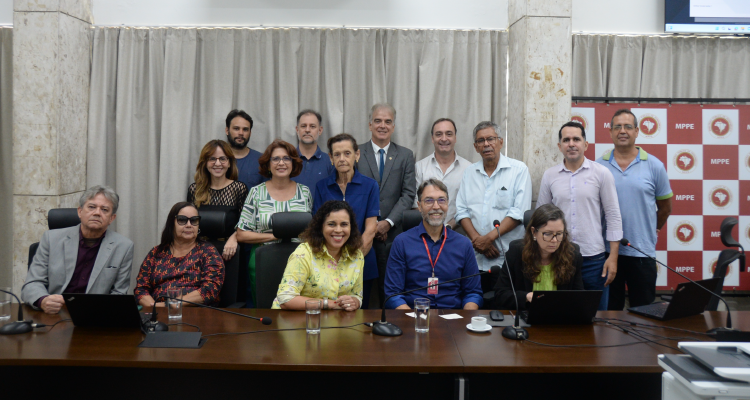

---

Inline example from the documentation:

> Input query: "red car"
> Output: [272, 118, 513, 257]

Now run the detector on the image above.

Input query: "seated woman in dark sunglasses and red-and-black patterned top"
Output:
[134, 201, 224, 307]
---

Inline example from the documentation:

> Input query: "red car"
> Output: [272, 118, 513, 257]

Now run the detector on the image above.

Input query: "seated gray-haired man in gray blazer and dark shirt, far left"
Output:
[21, 186, 133, 314]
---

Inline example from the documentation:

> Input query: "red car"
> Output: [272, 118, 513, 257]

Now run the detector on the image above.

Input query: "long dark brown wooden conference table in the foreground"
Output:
[0, 307, 750, 399]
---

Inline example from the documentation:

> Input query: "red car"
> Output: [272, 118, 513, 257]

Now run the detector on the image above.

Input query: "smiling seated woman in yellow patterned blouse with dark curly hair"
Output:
[271, 200, 365, 311]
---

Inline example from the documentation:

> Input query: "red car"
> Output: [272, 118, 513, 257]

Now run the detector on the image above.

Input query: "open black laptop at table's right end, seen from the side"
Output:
[628, 278, 721, 321]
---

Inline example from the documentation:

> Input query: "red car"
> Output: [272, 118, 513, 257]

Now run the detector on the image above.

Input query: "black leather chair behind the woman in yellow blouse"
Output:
[255, 212, 312, 308]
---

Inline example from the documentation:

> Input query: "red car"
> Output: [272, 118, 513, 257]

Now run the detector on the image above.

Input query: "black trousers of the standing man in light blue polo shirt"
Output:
[608, 255, 656, 310]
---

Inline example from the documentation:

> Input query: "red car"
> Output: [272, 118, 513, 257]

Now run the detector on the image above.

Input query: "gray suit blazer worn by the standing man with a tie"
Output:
[357, 141, 417, 241]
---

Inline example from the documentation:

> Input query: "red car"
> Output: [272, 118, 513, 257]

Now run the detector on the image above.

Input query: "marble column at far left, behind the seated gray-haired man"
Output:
[13, 0, 93, 294]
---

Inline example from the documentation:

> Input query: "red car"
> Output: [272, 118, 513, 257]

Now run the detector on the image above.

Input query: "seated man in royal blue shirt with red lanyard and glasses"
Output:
[385, 179, 482, 310]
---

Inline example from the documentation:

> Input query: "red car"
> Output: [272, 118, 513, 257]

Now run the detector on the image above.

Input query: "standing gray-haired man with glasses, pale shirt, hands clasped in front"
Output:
[456, 121, 531, 292]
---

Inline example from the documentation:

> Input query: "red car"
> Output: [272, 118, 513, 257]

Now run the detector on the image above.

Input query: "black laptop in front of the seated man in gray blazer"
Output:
[62, 293, 149, 329]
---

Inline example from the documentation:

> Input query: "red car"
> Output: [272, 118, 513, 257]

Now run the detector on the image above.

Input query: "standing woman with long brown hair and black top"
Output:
[187, 140, 248, 260]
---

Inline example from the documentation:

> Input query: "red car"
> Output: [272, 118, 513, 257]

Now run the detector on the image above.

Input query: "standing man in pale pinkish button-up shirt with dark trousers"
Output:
[536, 122, 622, 310]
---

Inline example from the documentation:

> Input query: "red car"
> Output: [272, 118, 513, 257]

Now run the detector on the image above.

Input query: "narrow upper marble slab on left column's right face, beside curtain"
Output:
[58, 14, 91, 193]
